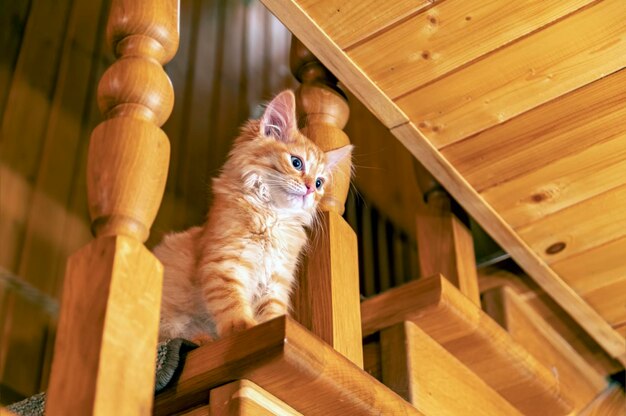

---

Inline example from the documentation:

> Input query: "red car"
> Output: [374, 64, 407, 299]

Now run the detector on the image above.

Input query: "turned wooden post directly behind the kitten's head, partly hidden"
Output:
[290, 37, 363, 367]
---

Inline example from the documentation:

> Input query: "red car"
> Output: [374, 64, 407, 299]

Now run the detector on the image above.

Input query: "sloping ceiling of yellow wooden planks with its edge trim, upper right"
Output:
[263, 0, 626, 363]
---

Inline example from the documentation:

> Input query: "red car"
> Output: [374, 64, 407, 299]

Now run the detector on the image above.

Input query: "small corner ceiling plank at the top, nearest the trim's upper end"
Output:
[297, 0, 436, 49]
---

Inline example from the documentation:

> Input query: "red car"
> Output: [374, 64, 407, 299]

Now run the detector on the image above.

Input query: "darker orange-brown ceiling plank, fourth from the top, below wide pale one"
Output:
[441, 70, 626, 195]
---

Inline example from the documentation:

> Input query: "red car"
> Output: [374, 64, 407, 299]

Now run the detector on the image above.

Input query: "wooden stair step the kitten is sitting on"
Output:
[154, 317, 421, 415]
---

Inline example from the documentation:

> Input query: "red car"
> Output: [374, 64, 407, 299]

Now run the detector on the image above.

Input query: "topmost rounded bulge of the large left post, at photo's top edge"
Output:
[107, 0, 180, 65]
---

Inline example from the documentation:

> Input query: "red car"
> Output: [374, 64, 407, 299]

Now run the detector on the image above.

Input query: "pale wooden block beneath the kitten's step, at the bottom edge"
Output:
[209, 379, 302, 416]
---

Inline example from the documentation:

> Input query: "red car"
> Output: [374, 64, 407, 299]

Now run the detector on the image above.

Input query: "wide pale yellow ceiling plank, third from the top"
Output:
[396, 0, 626, 148]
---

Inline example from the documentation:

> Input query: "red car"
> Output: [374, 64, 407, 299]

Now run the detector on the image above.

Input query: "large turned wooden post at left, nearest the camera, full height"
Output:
[46, 0, 179, 415]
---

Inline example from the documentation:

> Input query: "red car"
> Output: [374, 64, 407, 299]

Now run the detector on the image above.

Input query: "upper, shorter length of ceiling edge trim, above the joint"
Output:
[261, 0, 409, 128]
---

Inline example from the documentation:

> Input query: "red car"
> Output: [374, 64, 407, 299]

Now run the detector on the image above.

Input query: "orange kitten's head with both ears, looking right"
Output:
[225, 90, 352, 214]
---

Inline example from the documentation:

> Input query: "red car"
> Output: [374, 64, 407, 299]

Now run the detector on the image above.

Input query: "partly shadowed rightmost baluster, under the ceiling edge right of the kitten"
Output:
[415, 162, 480, 306]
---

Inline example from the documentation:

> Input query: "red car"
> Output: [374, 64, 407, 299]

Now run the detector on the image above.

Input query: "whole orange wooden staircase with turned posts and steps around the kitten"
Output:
[36, 0, 616, 416]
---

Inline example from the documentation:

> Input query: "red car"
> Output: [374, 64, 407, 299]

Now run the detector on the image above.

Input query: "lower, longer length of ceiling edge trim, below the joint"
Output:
[390, 123, 626, 364]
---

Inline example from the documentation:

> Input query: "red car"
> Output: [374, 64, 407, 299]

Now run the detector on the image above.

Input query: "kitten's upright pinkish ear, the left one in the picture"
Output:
[260, 90, 298, 142]
